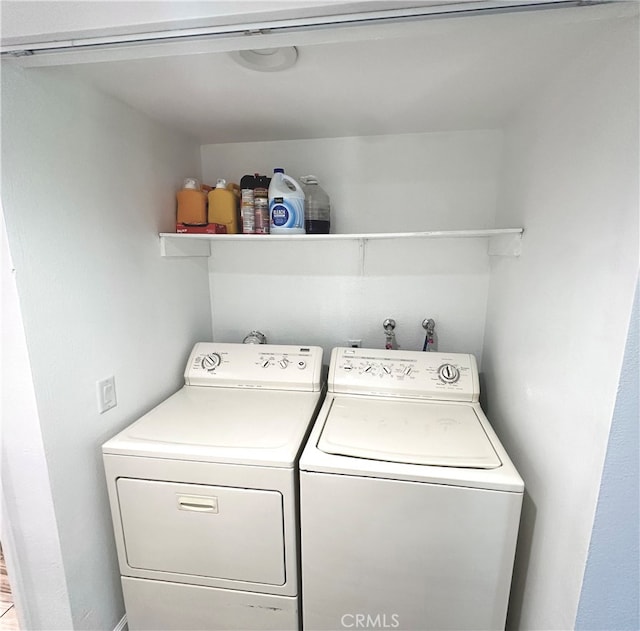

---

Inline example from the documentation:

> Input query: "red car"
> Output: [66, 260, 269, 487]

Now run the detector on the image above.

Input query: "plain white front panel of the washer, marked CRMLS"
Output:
[300, 471, 522, 631]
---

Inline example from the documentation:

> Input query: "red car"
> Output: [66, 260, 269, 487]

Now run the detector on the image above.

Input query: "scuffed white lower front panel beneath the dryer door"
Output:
[122, 576, 299, 631]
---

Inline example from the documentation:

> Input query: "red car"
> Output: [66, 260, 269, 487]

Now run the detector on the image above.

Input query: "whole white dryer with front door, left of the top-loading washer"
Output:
[102, 343, 322, 631]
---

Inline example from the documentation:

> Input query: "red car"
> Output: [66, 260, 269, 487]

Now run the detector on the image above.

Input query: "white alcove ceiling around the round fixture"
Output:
[26, 7, 629, 144]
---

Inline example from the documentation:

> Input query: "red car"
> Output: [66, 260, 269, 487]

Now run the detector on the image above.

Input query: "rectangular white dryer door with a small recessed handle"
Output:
[117, 478, 285, 585]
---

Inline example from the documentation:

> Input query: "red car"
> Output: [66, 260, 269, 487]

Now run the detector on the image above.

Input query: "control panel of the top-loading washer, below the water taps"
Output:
[329, 348, 480, 401]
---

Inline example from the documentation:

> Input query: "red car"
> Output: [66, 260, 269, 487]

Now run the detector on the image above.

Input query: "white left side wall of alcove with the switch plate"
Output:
[2, 62, 211, 630]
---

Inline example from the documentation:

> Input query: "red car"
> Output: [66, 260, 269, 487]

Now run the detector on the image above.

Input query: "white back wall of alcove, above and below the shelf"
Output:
[202, 131, 502, 357]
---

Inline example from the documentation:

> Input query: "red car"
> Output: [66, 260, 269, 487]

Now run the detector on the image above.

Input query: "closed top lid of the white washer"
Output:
[318, 398, 502, 469]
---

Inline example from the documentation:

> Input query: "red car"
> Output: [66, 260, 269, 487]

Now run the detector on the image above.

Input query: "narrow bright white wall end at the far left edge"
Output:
[0, 209, 72, 630]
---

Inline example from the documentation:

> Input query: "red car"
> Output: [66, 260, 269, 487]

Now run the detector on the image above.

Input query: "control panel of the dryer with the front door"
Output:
[184, 342, 322, 392]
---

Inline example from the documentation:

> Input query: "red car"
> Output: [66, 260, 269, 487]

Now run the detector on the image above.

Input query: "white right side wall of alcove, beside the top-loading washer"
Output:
[483, 14, 639, 629]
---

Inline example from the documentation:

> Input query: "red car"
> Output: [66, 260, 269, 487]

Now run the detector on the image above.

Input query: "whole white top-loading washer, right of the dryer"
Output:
[300, 348, 524, 631]
